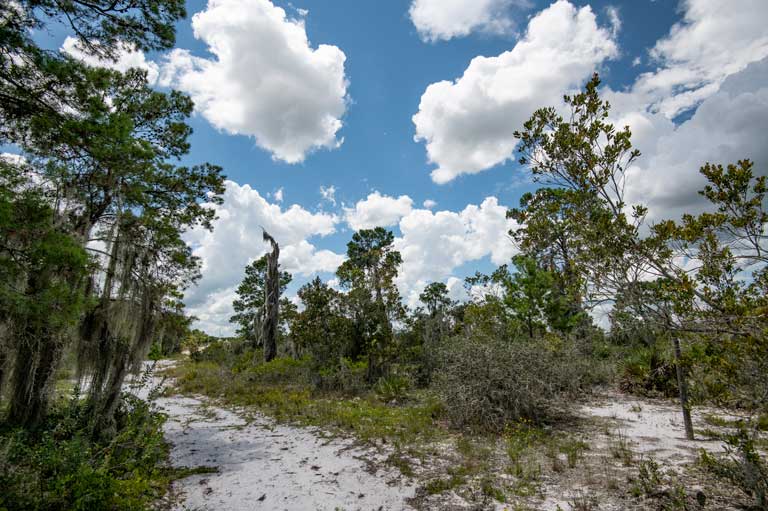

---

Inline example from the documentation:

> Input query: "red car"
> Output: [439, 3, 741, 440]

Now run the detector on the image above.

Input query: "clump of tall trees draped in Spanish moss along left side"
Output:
[0, 0, 223, 432]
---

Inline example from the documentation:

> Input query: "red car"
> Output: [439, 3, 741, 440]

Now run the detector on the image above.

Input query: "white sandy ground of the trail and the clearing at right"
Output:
[129, 364, 740, 511]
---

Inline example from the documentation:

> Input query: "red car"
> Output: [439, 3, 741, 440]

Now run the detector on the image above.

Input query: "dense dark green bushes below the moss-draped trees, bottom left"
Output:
[0, 396, 170, 511]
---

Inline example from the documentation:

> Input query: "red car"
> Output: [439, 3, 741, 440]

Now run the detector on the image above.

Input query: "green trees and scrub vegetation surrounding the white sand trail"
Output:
[0, 0, 768, 510]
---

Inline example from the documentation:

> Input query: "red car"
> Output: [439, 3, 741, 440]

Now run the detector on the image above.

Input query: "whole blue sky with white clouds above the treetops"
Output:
[52, 0, 768, 335]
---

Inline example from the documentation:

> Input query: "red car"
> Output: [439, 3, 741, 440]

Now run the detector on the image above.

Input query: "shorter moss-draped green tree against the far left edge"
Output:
[0, 159, 90, 424]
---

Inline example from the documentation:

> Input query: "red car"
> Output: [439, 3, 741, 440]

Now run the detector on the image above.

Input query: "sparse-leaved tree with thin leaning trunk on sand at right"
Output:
[515, 75, 765, 438]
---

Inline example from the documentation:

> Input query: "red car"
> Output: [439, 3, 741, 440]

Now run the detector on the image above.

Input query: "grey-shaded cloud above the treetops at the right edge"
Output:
[620, 58, 768, 220]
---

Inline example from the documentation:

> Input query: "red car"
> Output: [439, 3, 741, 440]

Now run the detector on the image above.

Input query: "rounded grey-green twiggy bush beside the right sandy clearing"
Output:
[435, 338, 586, 432]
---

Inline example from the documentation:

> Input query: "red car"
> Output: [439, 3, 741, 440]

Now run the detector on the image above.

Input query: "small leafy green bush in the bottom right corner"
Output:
[701, 425, 768, 509]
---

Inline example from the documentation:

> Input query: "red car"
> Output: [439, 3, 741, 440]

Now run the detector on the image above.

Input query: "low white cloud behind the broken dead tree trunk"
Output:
[184, 181, 344, 333]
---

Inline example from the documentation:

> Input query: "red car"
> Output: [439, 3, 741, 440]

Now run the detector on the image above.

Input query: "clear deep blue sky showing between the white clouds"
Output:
[172, 0, 680, 213]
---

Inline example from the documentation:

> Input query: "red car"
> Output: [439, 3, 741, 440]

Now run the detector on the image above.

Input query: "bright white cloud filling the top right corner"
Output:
[616, 0, 768, 118]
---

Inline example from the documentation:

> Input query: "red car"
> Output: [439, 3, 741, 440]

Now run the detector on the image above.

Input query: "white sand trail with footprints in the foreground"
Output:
[152, 390, 415, 511]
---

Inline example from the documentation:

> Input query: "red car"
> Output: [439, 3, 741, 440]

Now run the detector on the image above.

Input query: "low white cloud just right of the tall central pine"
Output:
[395, 197, 517, 306]
